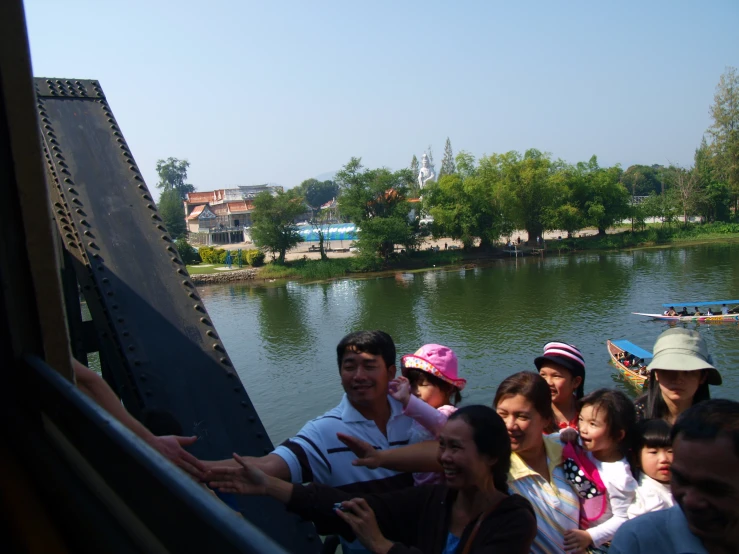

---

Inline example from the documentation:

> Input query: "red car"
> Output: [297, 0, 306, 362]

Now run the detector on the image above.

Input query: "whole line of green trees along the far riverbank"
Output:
[157, 67, 739, 261]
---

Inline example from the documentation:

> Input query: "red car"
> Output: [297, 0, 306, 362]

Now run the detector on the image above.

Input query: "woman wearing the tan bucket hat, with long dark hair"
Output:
[635, 328, 722, 423]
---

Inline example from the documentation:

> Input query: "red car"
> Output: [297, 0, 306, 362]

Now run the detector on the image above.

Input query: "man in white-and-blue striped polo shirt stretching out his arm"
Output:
[208, 331, 413, 553]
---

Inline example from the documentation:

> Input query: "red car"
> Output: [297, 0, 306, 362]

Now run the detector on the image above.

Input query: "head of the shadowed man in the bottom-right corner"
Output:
[670, 399, 739, 548]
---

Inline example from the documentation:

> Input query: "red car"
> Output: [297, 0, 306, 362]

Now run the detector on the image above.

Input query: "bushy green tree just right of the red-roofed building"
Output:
[251, 189, 306, 264]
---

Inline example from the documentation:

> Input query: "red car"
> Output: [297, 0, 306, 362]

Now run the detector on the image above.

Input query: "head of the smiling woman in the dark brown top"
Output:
[439, 405, 511, 493]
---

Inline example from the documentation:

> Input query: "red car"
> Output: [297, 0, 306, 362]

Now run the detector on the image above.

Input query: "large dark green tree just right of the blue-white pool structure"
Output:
[336, 158, 419, 262]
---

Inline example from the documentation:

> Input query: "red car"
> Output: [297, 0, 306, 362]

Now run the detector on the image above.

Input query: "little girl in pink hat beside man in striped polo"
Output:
[389, 344, 467, 485]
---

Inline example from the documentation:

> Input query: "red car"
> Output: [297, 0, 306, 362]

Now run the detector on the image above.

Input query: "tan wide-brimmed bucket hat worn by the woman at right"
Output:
[647, 328, 723, 385]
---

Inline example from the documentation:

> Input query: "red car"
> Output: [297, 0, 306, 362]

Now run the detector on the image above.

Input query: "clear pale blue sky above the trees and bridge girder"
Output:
[25, 0, 739, 196]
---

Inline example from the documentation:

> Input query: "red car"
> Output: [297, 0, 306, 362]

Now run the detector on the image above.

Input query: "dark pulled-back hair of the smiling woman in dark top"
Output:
[449, 404, 511, 494]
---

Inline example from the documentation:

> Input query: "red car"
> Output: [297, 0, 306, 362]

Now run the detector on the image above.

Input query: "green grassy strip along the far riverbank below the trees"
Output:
[187, 223, 739, 281]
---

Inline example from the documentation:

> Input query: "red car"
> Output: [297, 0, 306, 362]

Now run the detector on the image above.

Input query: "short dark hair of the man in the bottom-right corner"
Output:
[671, 398, 739, 456]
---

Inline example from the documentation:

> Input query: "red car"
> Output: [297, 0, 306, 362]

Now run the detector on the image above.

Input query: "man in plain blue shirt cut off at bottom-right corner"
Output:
[609, 399, 739, 554]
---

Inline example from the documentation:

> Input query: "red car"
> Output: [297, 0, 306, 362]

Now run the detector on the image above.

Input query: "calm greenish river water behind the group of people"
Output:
[200, 242, 739, 443]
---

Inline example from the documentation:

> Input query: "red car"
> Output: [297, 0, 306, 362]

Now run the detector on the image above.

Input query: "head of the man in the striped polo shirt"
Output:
[336, 331, 396, 408]
